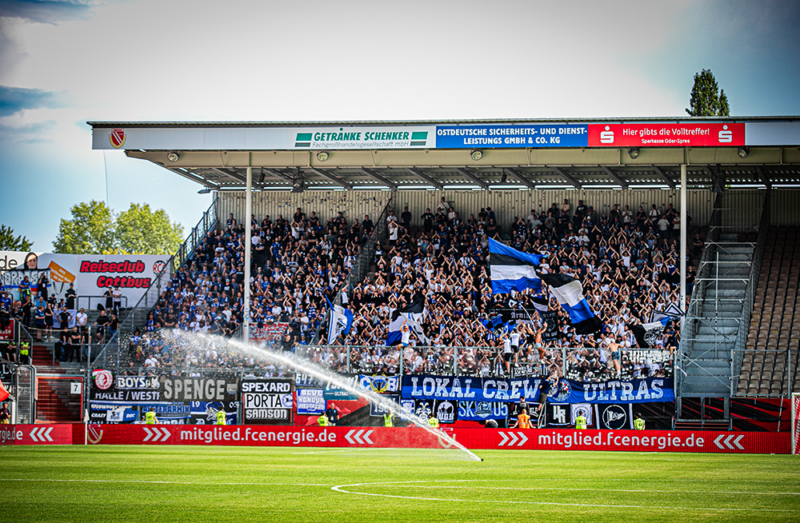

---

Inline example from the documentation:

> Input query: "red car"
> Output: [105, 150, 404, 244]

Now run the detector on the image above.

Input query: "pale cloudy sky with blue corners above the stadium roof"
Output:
[0, 0, 800, 251]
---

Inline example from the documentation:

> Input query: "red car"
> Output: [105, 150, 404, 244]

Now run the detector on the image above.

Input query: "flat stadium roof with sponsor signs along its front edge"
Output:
[89, 116, 800, 191]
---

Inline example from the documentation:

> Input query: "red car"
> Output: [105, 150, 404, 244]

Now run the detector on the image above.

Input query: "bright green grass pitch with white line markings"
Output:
[0, 446, 800, 523]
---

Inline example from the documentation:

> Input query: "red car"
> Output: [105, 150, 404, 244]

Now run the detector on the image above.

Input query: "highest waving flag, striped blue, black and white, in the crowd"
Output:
[489, 238, 542, 294]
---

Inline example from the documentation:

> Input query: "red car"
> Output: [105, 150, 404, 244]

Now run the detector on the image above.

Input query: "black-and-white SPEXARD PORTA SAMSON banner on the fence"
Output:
[240, 378, 294, 425]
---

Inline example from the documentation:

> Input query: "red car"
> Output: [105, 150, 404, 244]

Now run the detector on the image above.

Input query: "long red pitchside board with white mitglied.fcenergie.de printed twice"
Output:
[56, 425, 790, 454]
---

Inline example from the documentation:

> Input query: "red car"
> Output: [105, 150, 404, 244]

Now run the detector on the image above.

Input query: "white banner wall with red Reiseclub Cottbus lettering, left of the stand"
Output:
[0, 251, 169, 309]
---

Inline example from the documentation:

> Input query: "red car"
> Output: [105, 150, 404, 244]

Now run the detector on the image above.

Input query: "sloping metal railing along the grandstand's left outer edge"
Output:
[93, 199, 217, 366]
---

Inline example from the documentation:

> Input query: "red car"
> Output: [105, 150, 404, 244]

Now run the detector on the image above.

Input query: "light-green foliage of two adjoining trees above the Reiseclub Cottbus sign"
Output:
[53, 200, 183, 254]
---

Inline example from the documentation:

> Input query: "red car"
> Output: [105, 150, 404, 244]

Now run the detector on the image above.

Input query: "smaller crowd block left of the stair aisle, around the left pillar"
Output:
[122, 208, 362, 369]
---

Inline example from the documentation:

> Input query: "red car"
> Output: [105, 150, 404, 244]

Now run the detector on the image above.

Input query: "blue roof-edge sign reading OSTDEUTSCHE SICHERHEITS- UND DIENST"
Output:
[436, 124, 589, 149]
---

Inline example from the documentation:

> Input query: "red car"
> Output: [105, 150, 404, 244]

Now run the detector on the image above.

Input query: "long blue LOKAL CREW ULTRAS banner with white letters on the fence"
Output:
[401, 375, 675, 403]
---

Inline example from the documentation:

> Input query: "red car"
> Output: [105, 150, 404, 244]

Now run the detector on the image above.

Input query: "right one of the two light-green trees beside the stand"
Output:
[117, 203, 183, 254]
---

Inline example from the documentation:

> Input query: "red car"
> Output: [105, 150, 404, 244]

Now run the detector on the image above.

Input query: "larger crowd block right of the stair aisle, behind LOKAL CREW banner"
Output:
[317, 199, 702, 380]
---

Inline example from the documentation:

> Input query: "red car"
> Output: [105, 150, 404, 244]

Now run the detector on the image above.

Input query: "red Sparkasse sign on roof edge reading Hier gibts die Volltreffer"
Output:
[588, 122, 745, 147]
